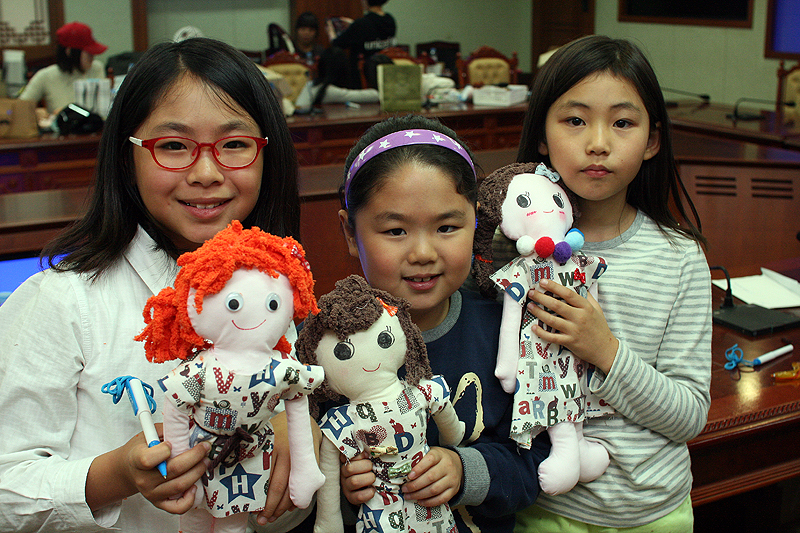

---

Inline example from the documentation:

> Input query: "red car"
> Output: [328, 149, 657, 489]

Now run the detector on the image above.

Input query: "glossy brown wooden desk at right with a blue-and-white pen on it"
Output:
[689, 259, 800, 506]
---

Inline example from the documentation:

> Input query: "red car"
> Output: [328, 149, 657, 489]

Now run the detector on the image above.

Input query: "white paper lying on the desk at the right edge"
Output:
[712, 268, 800, 309]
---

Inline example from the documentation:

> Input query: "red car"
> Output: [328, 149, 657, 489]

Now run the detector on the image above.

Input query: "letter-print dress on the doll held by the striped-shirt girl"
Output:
[492, 252, 613, 449]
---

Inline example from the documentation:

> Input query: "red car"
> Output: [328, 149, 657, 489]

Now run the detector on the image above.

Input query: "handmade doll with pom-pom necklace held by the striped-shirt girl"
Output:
[473, 163, 609, 494]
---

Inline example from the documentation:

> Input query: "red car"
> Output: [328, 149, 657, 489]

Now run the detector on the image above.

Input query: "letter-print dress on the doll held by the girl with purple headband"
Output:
[320, 375, 455, 533]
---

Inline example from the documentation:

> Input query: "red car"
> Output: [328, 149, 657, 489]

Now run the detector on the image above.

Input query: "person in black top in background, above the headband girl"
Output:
[326, 0, 397, 89]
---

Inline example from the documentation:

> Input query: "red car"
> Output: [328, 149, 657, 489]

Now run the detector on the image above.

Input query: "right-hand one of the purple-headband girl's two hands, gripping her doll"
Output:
[403, 446, 464, 507]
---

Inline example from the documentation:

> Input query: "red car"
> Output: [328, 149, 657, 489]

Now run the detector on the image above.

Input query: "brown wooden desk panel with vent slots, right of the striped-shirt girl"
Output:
[670, 104, 800, 269]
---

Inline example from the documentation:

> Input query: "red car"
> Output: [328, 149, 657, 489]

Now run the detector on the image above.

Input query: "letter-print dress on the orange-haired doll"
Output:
[159, 351, 324, 518]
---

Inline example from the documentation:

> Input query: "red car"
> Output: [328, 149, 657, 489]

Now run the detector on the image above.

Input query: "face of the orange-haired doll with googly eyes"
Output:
[187, 268, 294, 353]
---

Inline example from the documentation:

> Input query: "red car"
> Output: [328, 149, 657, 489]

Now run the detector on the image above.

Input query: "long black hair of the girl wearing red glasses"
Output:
[42, 38, 300, 277]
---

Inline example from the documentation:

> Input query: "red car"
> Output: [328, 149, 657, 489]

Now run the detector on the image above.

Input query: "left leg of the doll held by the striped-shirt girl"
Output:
[539, 422, 580, 495]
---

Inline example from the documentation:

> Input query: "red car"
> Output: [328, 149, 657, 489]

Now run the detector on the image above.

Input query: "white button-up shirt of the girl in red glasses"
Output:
[0, 228, 306, 533]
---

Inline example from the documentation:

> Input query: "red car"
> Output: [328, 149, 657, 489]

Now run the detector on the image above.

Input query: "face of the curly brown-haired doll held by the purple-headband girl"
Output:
[316, 310, 406, 399]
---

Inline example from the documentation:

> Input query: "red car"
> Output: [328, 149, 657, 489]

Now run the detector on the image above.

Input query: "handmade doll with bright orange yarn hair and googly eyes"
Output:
[136, 221, 324, 532]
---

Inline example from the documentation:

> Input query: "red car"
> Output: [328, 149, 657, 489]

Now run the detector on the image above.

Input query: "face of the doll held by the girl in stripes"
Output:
[500, 174, 572, 240]
